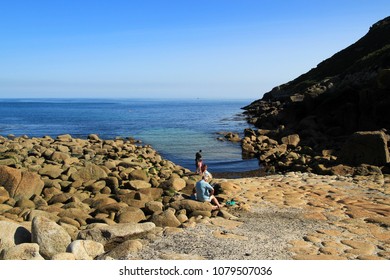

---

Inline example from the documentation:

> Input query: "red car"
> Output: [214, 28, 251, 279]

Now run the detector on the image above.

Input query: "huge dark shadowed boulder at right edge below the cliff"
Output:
[340, 131, 390, 166]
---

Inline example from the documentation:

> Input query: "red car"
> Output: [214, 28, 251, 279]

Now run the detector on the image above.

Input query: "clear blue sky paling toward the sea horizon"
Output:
[0, 0, 390, 99]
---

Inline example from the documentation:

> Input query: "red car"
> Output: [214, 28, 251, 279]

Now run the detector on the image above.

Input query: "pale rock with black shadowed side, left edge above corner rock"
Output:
[0, 221, 31, 252]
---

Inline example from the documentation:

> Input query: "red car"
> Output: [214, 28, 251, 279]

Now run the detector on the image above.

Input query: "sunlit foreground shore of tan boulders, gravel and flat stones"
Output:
[0, 135, 390, 260]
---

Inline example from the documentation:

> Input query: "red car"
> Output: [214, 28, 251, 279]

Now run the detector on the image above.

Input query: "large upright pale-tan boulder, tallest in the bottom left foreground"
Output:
[31, 216, 71, 259]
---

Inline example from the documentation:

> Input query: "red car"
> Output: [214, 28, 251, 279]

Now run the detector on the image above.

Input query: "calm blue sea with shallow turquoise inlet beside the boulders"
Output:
[0, 99, 258, 172]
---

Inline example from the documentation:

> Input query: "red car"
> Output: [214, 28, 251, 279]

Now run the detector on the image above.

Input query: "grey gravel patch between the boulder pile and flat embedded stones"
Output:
[133, 205, 329, 260]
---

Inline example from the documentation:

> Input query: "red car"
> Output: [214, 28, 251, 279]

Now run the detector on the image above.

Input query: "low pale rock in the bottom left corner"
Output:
[0, 243, 44, 260]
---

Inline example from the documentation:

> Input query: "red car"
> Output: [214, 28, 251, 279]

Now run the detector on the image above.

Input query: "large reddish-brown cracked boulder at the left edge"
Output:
[0, 166, 44, 200]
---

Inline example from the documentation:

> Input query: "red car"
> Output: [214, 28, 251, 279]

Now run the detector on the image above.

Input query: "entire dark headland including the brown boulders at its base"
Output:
[238, 17, 390, 175]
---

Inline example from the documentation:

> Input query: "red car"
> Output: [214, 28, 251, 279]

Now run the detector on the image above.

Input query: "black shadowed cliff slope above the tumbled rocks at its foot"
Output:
[243, 17, 390, 151]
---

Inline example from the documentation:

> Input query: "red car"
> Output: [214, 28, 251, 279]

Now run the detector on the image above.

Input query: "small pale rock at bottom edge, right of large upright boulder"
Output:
[66, 240, 104, 260]
